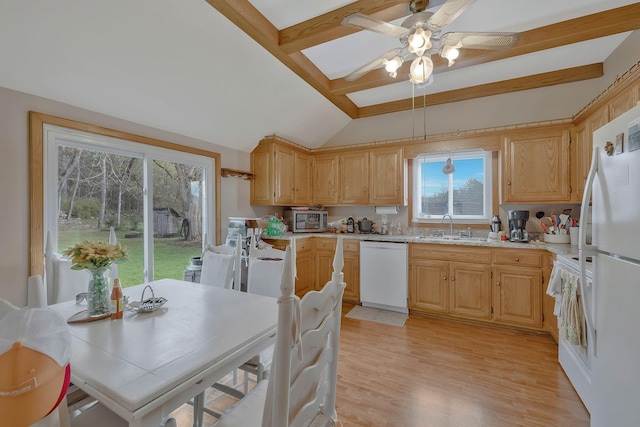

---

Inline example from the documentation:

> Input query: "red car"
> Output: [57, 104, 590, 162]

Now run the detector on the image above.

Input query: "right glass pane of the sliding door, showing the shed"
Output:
[153, 160, 205, 280]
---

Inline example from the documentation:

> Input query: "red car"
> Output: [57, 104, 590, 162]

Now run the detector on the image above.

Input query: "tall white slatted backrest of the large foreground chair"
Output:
[262, 237, 345, 427]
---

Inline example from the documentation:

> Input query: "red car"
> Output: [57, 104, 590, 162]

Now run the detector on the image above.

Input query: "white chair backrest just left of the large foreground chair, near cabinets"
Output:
[247, 236, 285, 298]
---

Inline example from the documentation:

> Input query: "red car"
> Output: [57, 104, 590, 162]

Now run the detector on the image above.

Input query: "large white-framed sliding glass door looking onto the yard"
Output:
[44, 125, 215, 286]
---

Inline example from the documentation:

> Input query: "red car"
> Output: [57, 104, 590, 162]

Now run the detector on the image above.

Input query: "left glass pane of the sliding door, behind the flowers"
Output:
[57, 145, 143, 286]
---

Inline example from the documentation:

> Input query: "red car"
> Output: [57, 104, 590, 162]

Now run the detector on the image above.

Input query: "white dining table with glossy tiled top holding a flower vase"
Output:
[50, 279, 278, 427]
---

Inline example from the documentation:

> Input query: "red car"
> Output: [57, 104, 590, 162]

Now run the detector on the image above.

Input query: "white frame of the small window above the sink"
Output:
[412, 150, 493, 224]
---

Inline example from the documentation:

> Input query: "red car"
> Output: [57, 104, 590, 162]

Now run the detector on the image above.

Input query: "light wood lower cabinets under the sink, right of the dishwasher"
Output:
[409, 243, 548, 330]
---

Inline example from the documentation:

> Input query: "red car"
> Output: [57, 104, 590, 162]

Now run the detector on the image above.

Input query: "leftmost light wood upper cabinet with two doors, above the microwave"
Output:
[251, 139, 311, 206]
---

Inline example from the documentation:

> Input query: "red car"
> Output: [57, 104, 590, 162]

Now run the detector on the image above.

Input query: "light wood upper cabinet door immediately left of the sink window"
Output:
[369, 147, 405, 205]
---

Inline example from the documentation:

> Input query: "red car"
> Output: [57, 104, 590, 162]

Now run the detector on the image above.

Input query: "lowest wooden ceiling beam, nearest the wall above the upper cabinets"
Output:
[359, 62, 604, 118]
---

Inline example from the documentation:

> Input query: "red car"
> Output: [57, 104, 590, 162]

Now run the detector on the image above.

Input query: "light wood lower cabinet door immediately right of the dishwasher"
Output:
[409, 259, 449, 313]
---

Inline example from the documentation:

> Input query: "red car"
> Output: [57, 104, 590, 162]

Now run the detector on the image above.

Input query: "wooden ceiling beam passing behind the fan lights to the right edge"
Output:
[329, 3, 640, 95]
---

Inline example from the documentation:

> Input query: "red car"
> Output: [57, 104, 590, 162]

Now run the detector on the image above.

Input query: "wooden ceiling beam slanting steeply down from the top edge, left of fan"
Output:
[207, 0, 358, 118]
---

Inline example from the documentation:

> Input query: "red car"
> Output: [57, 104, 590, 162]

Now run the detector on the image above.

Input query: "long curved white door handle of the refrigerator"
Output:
[578, 146, 600, 356]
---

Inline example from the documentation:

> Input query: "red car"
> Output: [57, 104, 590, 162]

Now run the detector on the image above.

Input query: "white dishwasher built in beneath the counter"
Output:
[360, 240, 409, 313]
